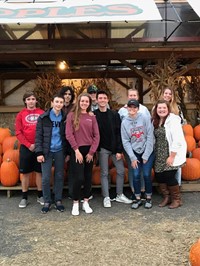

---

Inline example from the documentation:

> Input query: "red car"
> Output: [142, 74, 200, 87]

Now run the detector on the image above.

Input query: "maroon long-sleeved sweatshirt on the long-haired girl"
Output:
[65, 112, 100, 155]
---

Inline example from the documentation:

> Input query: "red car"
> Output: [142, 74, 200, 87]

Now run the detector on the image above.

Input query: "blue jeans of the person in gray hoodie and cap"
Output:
[132, 153, 155, 197]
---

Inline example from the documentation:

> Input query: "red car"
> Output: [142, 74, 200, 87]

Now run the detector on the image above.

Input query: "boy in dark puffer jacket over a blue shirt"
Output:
[35, 94, 67, 213]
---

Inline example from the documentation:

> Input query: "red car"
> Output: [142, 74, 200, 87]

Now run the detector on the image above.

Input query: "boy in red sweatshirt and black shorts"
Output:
[15, 91, 44, 208]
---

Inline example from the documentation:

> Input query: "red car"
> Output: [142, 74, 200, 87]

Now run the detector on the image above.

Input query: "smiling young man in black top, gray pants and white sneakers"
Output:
[94, 90, 132, 208]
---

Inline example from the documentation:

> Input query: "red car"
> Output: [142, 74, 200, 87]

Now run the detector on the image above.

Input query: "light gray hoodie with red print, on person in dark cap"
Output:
[121, 113, 154, 162]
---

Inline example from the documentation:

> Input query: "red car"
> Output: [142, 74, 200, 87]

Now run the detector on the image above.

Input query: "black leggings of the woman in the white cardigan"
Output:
[155, 170, 178, 186]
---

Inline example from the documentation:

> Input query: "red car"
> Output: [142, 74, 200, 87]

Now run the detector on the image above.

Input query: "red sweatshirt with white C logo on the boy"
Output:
[15, 108, 44, 148]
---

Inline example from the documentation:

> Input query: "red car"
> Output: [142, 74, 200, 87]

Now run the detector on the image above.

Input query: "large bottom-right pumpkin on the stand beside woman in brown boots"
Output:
[182, 158, 200, 180]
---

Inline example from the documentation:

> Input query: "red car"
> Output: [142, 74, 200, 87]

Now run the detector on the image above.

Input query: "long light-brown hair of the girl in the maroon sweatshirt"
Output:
[73, 92, 92, 130]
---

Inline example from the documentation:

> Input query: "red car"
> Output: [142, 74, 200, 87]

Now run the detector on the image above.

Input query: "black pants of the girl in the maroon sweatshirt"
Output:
[70, 146, 93, 200]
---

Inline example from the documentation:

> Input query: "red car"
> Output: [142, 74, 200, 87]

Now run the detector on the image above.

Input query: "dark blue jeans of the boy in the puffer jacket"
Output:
[42, 150, 64, 203]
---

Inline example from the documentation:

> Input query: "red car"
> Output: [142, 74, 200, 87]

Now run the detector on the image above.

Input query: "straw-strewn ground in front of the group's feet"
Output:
[0, 189, 200, 266]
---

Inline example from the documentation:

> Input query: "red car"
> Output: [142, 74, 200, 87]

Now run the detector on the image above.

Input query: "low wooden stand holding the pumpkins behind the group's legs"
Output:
[0, 180, 200, 198]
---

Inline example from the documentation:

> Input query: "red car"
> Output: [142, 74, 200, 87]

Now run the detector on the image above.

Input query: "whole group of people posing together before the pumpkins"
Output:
[15, 85, 186, 216]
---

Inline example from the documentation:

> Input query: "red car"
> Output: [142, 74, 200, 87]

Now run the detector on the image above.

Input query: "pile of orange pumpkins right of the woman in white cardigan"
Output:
[182, 124, 200, 181]
